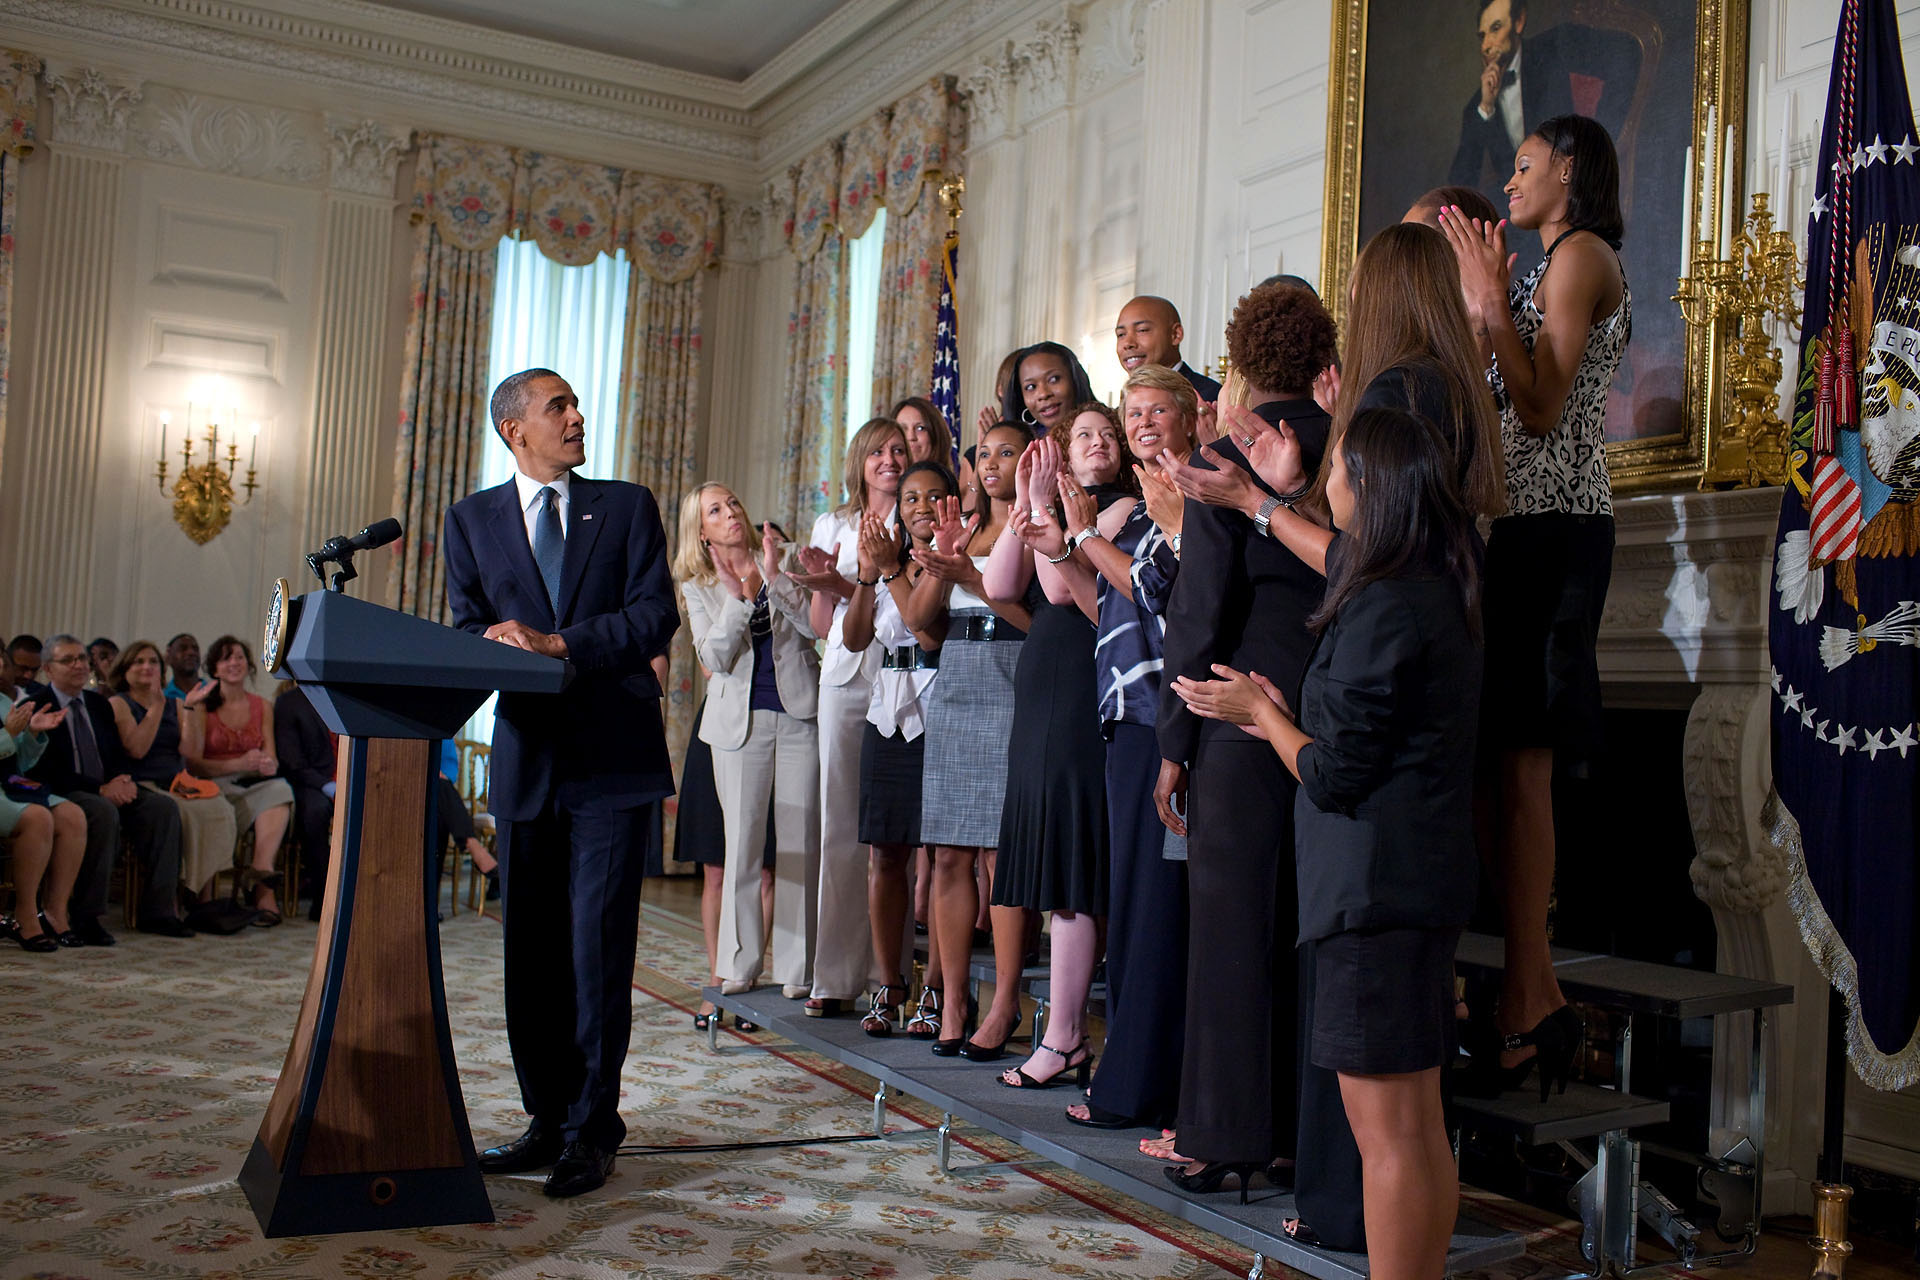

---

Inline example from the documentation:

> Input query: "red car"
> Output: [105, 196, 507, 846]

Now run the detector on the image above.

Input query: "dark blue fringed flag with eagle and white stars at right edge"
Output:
[1768, 0, 1920, 1090]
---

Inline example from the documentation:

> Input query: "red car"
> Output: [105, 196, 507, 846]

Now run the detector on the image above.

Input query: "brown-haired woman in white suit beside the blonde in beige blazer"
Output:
[795, 418, 906, 1017]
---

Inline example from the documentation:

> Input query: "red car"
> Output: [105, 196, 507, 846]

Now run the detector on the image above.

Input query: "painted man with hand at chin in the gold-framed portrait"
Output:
[1448, 0, 1640, 189]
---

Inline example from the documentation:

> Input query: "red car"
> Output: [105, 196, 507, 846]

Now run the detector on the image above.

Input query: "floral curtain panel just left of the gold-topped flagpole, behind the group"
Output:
[874, 77, 964, 413]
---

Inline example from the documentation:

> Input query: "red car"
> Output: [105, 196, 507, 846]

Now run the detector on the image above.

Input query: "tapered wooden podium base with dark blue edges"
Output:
[240, 737, 493, 1238]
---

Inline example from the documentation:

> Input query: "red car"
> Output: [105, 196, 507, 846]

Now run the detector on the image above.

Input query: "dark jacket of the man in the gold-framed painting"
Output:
[1446, 23, 1640, 189]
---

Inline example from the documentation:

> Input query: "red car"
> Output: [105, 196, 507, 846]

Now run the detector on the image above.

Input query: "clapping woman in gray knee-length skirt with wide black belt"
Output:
[900, 422, 1033, 1057]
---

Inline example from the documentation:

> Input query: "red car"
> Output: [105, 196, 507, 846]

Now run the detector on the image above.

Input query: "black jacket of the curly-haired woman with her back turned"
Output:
[1160, 399, 1332, 764]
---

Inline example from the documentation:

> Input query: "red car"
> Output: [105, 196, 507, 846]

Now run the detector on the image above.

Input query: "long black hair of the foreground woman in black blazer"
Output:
[1308, 409, 1480, 639]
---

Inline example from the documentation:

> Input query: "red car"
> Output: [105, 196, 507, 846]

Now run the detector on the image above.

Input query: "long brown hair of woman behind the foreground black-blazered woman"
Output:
[1321, 223, 1507, 518]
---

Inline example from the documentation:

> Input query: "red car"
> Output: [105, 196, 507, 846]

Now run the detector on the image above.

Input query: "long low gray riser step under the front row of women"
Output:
[703, 986, 1526, 1280]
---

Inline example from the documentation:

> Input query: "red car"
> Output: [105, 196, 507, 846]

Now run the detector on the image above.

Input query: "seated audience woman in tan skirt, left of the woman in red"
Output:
[111, 641, 238, 902]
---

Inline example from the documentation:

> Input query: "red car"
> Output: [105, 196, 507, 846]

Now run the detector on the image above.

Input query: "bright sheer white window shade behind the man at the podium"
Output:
[463, 236, 630, 743]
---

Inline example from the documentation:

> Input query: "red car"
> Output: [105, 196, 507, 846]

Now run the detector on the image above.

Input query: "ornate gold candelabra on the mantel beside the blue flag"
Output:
[1674, 192, 1801, 489]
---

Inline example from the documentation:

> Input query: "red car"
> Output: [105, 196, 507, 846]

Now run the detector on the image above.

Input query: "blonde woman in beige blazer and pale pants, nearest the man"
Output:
[674, 484, 820, 1000]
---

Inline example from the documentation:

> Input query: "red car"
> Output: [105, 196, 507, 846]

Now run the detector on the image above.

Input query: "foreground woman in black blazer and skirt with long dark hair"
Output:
[1173, 409, 1480, 1276]
